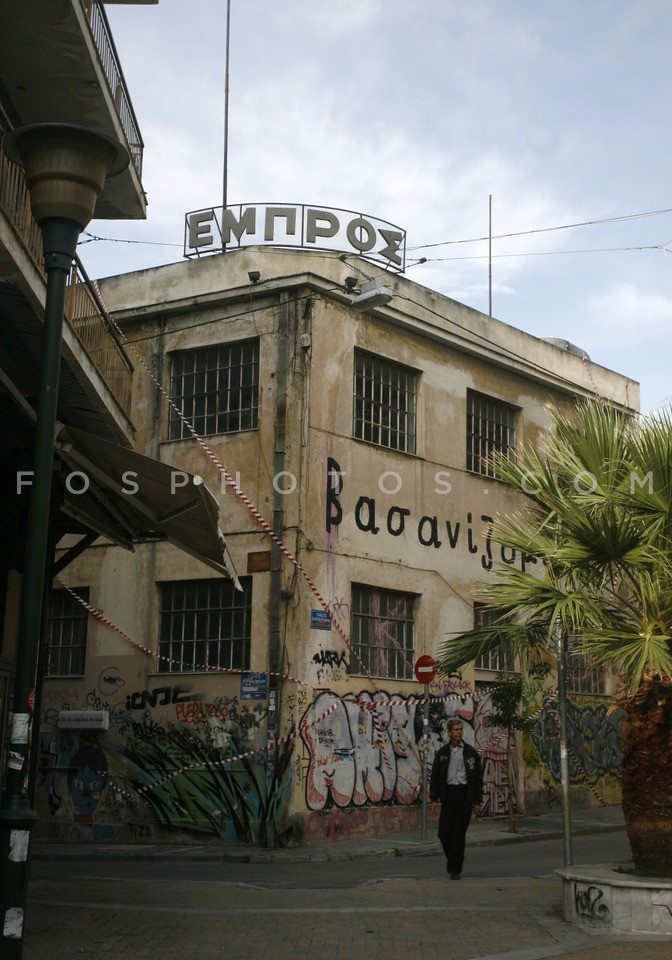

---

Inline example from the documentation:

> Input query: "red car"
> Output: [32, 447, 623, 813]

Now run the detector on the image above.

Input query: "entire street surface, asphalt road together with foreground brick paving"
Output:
[24, 831, 672, 960]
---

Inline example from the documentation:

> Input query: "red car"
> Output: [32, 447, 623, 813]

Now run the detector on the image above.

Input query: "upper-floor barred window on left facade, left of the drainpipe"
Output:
[169, 339, 259, 440]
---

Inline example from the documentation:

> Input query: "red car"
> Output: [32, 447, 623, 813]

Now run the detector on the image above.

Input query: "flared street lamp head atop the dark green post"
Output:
[3, 123, 129, 230]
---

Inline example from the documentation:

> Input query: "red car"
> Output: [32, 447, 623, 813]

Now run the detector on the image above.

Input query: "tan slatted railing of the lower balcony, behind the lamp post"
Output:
[0, 134, 133, 419]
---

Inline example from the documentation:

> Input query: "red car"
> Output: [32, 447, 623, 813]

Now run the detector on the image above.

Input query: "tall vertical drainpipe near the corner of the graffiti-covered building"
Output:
[265, 293, 289, 847]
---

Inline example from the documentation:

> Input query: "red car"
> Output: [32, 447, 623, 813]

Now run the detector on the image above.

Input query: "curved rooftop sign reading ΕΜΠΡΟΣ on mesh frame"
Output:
[184, 203, 406, 273]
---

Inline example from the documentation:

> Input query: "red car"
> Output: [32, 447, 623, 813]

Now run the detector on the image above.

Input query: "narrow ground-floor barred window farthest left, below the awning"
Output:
[47, 587, 89, 677]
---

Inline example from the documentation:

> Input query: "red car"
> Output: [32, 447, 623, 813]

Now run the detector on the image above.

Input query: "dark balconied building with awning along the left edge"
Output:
[0, 0, 226, 852]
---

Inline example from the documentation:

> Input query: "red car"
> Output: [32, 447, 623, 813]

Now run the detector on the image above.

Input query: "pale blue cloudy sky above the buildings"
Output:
[84, 0, 672, 411]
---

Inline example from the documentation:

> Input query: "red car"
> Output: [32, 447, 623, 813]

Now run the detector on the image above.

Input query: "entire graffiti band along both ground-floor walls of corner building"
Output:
[39, 663, 624, 844]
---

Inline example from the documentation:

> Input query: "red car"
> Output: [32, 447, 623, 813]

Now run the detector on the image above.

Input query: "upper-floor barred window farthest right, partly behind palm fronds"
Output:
[467, 390, 517, 477]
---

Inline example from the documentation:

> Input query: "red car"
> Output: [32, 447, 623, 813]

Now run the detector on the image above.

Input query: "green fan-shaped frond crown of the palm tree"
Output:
[452, 402, 672, 690]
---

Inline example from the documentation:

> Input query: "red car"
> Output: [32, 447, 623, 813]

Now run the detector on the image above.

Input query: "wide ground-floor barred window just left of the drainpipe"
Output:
[158, 577, 252, 673]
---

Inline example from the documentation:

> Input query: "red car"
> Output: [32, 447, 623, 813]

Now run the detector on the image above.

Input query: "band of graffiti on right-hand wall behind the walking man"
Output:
[300, 681, 625, 815]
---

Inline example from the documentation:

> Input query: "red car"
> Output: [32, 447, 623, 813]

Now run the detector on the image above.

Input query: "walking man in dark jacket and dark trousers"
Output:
[429, 717, 483, 880]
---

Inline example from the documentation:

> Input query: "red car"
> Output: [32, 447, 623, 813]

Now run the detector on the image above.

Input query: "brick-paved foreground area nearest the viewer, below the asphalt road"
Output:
[24, 876, 672, 960]
